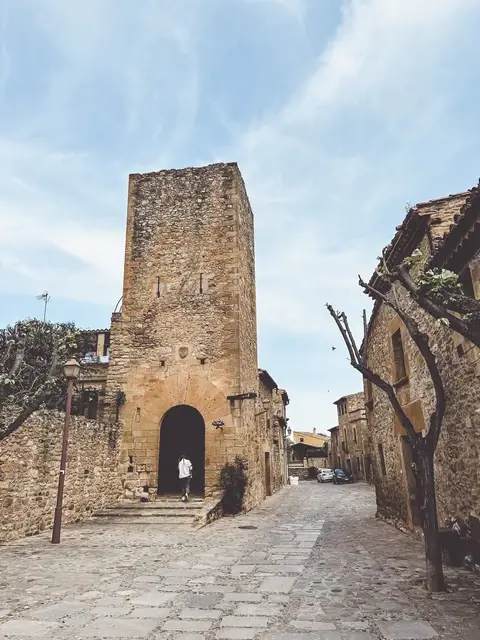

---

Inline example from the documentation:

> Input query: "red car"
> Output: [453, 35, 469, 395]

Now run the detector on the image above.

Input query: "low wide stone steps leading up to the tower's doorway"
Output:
[93, 497, 205, 529]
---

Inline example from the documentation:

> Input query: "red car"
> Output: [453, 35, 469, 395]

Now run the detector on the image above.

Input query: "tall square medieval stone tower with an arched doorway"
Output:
[107, 163, 263, 504]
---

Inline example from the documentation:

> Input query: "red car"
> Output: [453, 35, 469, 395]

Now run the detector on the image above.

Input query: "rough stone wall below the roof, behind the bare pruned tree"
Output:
[367, 241, 480, 528]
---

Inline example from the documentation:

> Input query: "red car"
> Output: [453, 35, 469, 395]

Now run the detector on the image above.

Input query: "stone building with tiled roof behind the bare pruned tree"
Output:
[365, 188, 480, 528]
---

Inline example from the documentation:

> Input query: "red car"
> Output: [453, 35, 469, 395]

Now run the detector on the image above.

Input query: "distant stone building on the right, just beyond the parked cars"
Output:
[330, 391, 371, 480]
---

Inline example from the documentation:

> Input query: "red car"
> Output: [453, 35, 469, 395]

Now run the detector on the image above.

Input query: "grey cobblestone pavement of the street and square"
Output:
[0, 482, 480, 640]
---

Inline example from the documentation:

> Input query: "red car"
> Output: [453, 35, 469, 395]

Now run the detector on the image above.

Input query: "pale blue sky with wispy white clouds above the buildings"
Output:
[0, 0, 480, 430]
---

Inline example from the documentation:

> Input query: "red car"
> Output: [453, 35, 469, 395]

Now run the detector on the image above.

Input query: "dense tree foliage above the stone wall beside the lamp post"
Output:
[0, 319, 92, 439]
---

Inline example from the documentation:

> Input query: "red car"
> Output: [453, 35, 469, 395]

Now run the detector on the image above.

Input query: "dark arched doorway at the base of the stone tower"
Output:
[158, 404, 205, 496]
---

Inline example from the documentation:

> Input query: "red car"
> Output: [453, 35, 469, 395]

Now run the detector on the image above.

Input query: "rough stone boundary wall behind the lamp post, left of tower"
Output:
[0, 411, 122, 542]
